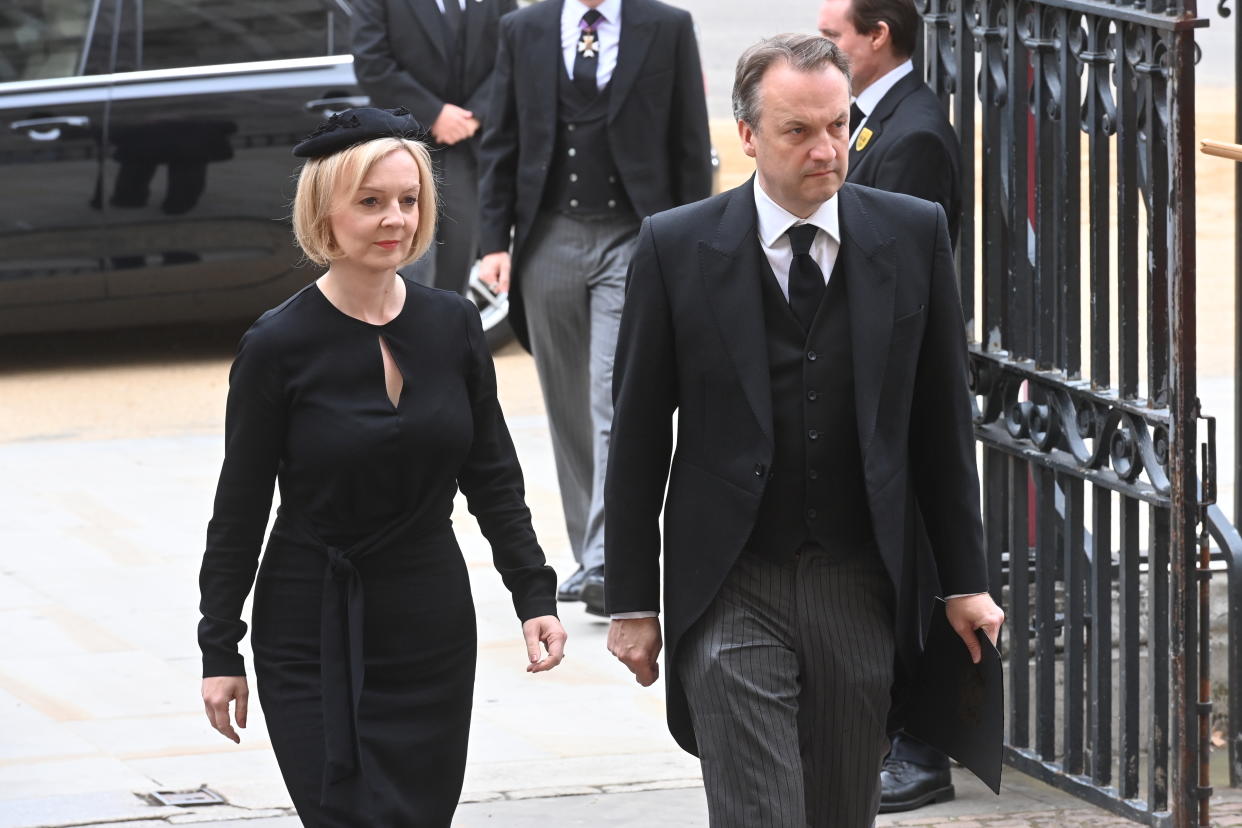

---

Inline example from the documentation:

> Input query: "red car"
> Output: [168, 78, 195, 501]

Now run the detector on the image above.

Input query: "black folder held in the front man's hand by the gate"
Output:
[905, 600, 1005, 793]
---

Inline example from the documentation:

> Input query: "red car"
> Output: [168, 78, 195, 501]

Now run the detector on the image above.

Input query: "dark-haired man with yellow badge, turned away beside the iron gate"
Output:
[818, 0, 961, 813]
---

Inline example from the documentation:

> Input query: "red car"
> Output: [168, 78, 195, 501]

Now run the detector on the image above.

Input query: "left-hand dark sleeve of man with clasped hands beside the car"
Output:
[349, 0, 448, 129]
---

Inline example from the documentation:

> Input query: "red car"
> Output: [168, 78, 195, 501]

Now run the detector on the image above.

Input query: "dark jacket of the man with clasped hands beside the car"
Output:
[350, 0, 517, 139]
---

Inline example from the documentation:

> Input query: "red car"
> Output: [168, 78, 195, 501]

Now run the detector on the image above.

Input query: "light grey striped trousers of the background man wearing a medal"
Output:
[519, 212, 638, 570]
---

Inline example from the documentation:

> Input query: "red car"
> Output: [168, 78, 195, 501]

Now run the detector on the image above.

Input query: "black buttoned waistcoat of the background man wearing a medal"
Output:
[543, 66, 633, 217]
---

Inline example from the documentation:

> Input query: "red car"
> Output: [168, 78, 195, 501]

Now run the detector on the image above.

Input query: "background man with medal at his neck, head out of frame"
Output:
[479, 0, 712, 614]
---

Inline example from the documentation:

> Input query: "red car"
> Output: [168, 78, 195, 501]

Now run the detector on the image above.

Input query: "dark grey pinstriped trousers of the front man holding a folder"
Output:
[677, 546, 894, 828]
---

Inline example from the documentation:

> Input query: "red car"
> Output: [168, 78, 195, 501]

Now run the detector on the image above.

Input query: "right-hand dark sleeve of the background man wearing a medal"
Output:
[668, 14, 712, 205]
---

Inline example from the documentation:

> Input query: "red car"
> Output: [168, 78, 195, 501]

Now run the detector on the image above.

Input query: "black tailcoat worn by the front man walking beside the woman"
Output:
[605, 180, 987, 752]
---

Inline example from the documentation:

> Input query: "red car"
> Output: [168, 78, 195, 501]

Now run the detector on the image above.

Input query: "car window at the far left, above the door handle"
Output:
[0, 0, 107, 83]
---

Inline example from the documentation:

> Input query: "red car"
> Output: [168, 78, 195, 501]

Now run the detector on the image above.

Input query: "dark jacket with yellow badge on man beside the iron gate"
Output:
[846, 70, 961, 242]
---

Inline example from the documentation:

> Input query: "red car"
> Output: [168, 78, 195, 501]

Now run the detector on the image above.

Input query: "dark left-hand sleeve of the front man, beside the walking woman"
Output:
[604, 218, 678, 613]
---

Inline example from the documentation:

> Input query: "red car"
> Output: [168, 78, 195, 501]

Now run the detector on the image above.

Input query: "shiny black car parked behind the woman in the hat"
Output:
[0, 0, 509, 346]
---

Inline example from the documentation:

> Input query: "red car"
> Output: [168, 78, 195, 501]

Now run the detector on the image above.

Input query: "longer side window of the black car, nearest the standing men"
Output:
[118, 0, 349, 70]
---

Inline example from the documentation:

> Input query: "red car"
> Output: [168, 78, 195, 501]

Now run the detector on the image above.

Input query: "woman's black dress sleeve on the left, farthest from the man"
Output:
[199, 328, 284, 678]
